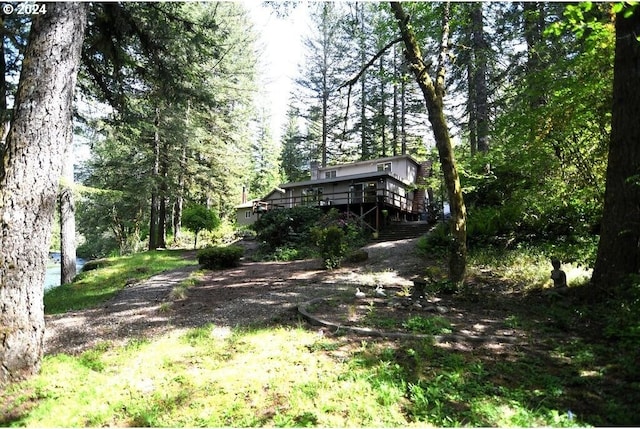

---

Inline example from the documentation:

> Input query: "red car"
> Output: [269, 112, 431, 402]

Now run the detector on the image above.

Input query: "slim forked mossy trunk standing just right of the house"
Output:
[391, 2, 467, 284]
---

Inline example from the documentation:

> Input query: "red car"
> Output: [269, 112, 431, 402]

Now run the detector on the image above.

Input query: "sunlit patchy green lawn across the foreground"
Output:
[0, 325, 584, 427]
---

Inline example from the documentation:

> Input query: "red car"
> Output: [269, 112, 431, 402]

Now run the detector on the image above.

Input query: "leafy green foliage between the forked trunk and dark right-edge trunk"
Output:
[436, 3, 614, 252]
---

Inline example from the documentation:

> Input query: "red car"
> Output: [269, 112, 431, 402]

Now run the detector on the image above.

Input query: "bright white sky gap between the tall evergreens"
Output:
[243, 0, 309, 141]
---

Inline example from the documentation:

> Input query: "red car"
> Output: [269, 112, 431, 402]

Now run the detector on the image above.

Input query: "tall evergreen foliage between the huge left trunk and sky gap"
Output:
[77, 3, 262, 256]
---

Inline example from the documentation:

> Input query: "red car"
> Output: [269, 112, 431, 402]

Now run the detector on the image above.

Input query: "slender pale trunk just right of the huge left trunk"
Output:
[58, 148, 76, 284]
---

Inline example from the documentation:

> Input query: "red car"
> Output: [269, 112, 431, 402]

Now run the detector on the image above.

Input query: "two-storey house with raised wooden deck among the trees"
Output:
[237, 155, 431, 232]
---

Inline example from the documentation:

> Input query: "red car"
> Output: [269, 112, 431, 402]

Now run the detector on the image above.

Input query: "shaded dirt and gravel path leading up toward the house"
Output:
[45, 239, 521, 353]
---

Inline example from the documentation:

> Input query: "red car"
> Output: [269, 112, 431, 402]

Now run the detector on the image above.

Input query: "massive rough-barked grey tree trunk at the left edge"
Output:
[0, 2, 87, 385]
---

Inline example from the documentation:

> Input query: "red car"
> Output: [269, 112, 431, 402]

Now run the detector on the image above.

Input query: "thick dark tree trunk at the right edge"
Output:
[592, 10, 640, 289]
